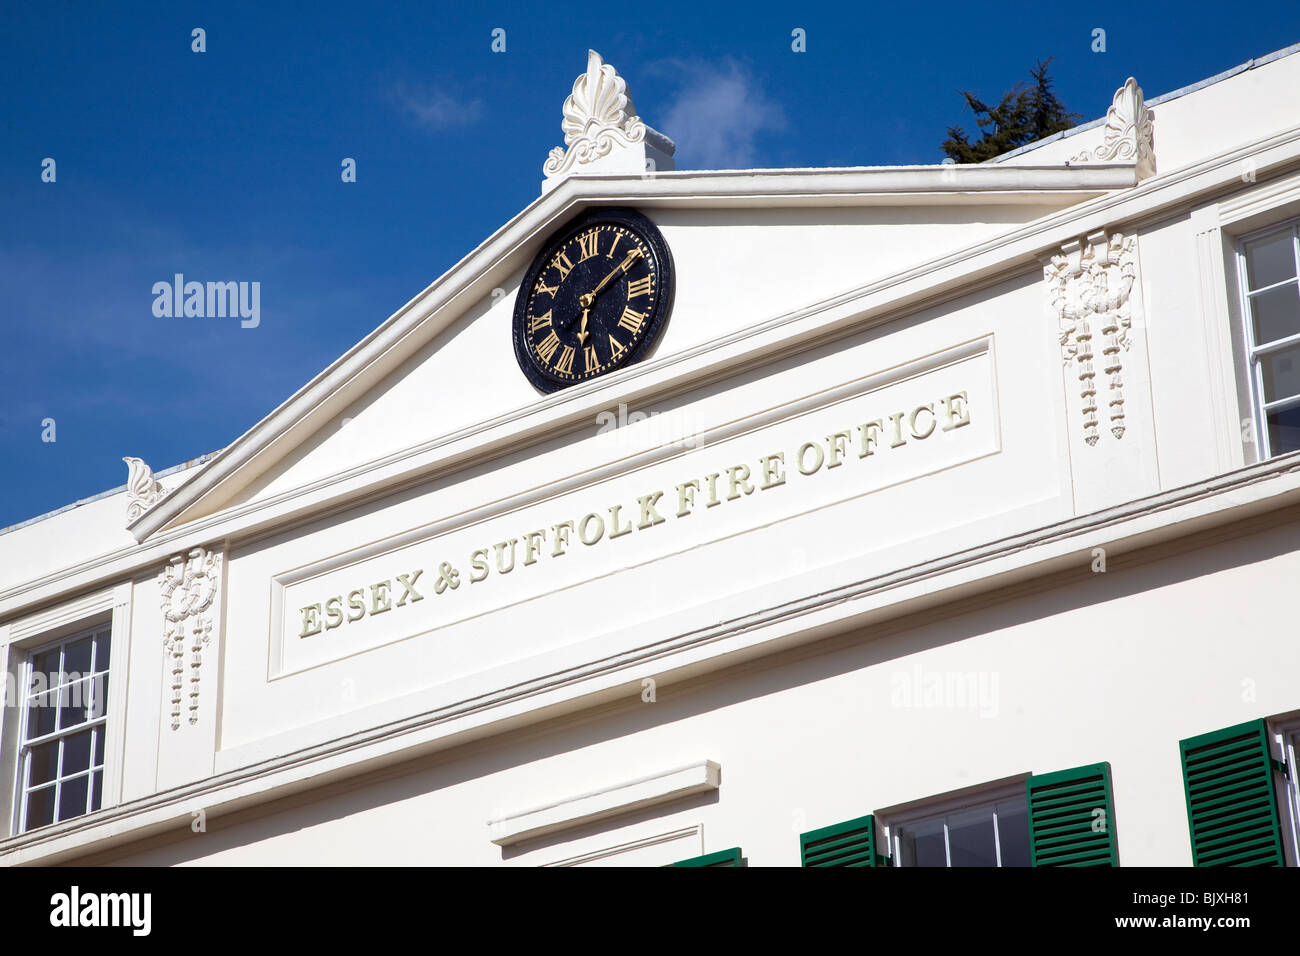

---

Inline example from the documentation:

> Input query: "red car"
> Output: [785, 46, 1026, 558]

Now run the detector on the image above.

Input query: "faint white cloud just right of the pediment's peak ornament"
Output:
[650, 59, 785, 169]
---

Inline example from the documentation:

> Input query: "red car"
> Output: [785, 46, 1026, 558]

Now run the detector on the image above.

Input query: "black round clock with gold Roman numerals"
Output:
[514, 208, 672, 392]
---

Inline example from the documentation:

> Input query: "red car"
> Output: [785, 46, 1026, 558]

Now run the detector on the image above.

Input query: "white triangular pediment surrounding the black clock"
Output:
[130, 166, 1132, 540]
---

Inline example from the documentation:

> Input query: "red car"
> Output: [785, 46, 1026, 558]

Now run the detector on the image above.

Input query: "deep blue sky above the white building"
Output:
[0, 0, 1300, 527]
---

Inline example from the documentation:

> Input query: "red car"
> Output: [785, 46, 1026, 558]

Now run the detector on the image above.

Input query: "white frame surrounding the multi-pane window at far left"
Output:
[0, 583, 133, 839]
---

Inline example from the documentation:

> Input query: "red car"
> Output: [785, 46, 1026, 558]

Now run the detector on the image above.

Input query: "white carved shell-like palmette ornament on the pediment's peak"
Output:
[542, 49, 646, 177]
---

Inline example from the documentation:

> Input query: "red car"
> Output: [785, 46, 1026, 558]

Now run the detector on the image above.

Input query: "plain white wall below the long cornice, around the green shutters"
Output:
[89, 515, 1300, 866]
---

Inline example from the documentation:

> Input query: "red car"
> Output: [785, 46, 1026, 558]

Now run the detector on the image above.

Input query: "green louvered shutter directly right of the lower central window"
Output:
[1024, 763, 1119, 866]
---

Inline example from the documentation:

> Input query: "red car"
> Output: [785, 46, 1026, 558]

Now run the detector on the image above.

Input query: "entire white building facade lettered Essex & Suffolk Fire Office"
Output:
[0, 47, 1300, 866]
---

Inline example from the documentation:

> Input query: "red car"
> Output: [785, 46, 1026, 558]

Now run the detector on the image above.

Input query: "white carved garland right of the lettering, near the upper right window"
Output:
[1044, 233, 1138, 445]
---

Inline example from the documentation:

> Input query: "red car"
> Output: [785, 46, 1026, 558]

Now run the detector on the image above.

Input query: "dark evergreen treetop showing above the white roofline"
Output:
[941, 57, 1080, 163]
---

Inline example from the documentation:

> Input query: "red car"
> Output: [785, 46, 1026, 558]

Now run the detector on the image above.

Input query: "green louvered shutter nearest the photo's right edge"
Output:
[1178, 721, 1286, 866]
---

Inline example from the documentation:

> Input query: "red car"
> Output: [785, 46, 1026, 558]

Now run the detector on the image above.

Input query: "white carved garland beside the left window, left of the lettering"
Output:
[159, 548, 221, 730]
